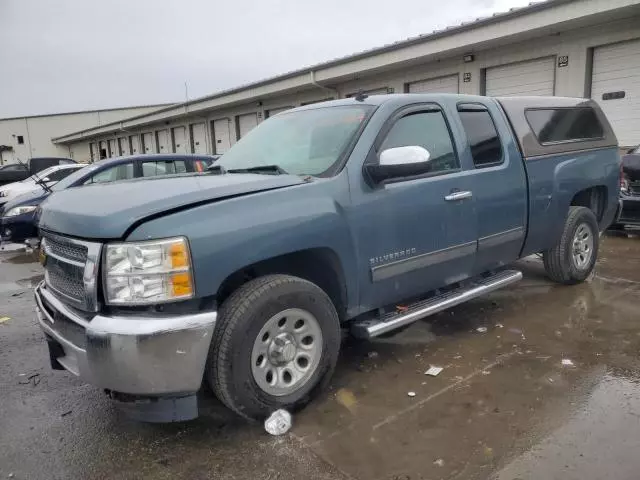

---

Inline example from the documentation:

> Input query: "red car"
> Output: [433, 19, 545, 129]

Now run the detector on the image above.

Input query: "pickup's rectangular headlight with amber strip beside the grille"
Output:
[103, 237, 194, 305]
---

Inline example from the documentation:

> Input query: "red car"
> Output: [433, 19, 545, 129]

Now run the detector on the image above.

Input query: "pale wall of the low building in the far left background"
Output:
[0, 106, 168, 163]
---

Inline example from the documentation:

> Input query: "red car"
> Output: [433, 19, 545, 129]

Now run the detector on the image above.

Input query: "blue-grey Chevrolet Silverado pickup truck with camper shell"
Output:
[35, 94, 620, 421]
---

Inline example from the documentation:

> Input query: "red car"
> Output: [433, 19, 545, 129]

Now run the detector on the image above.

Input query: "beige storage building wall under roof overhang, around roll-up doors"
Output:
[63, 12, 640, 153]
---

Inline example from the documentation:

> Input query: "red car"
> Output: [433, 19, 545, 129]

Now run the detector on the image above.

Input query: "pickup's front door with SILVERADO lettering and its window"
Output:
[355, 105, 477, 308]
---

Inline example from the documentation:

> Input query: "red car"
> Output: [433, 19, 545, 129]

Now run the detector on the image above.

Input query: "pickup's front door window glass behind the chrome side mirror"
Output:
[380, 110, 460, 173]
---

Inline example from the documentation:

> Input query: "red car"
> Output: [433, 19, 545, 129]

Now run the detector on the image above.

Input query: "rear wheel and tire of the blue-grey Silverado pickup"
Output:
[543, 207, 600, 285]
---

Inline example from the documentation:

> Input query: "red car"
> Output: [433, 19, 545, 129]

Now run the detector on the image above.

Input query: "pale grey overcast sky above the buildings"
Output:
[0, 0, 528, 118]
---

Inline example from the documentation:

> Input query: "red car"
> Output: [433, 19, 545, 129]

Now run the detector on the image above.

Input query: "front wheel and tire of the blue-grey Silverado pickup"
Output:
[205, 275, 340, 420]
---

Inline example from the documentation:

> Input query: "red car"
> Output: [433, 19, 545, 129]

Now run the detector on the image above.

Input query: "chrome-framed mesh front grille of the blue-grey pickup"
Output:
[43, 233, 100, 311]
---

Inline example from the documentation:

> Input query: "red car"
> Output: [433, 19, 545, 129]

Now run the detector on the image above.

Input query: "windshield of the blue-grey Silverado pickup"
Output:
[214, 105, 373, 175]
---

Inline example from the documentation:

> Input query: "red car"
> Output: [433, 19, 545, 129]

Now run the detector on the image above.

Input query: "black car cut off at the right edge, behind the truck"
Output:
[611, 146, 640, 230]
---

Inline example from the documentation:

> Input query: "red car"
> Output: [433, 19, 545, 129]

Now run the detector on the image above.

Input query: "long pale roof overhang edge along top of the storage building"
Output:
[52, 0, 640, 144]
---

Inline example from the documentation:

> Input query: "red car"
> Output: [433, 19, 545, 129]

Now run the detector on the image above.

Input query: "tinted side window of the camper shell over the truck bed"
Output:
[524, 107, 604, 144]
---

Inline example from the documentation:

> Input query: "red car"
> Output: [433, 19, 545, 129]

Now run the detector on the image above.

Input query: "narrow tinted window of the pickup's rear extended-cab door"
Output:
[458, 106, 502, 168]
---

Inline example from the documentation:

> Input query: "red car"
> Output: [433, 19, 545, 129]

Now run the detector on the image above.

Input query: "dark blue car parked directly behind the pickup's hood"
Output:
[0, 154, 215, 243]
